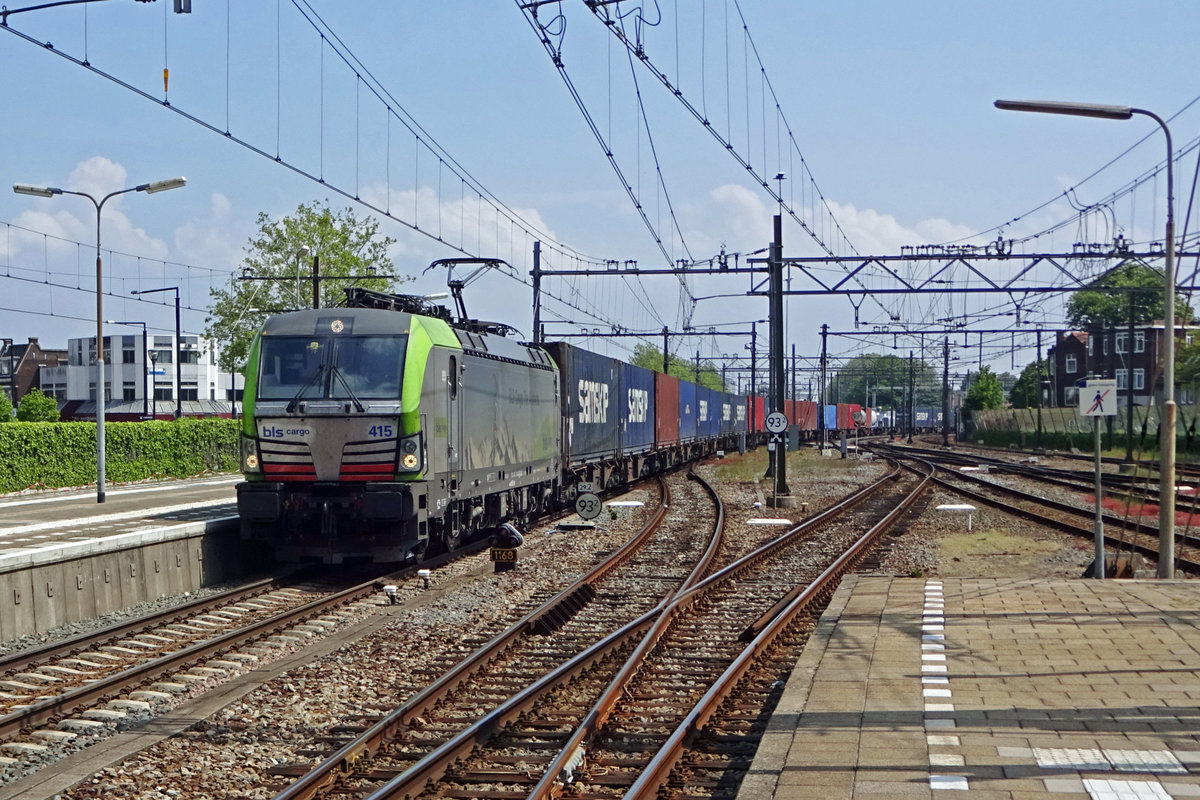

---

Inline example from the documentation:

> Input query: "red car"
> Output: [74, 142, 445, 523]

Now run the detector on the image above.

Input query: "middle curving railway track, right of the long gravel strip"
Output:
[270, 470, 721, 800]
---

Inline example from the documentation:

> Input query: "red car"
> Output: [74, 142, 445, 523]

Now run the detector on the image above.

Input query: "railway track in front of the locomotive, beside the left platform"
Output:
[0, 543, 501, 772]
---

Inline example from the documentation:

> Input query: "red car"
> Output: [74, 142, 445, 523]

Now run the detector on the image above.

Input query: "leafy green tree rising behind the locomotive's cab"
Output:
[204, 201, 412, 372]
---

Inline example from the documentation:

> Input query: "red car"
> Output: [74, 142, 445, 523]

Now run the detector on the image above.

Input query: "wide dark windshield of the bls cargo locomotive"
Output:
[258, 336, 408, 401]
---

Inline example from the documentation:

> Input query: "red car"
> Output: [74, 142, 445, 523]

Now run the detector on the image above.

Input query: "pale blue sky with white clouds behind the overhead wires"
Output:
[0, 0, 1200, 388]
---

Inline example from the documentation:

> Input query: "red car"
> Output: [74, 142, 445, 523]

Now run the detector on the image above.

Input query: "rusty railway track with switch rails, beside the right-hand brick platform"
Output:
[316, 460, 925, 800]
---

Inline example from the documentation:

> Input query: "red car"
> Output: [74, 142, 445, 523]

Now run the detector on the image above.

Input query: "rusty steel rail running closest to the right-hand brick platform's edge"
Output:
[624, 460, 932, 800]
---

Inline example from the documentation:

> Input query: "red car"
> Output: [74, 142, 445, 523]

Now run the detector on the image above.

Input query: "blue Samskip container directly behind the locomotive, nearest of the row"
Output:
[545, 342, 622, 464]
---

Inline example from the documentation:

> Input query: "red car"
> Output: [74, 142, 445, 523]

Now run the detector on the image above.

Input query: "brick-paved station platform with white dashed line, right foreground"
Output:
[738, 576, 1200, 800]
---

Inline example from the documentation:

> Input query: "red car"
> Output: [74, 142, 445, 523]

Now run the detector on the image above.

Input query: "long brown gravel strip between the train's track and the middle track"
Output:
[46, 489, 656, 800]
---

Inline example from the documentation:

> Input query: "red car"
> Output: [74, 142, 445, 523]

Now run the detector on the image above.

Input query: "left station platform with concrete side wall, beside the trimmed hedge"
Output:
[0, 475, 243, 642]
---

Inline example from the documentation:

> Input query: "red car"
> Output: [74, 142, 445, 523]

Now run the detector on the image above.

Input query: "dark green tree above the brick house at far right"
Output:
[1067, 261, 1195, 329]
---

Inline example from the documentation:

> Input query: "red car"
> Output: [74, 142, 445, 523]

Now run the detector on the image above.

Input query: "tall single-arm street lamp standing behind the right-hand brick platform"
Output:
[996, 100, 1176, 578]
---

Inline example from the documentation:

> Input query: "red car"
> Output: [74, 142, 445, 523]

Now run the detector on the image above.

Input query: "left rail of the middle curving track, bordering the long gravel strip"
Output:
[275, 477, 671, 800]
